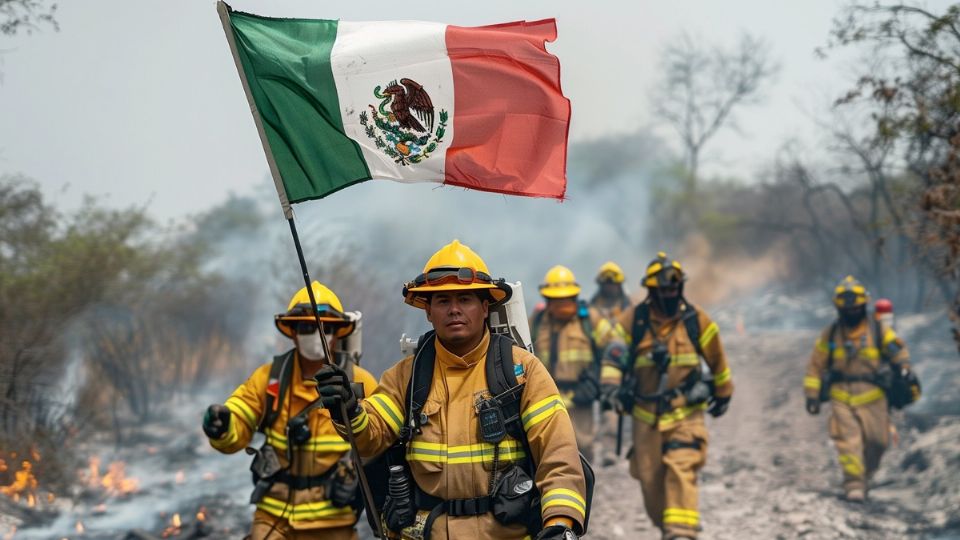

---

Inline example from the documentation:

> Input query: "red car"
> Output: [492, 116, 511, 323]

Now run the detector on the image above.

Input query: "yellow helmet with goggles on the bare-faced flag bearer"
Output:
[403, 240, 511, 309]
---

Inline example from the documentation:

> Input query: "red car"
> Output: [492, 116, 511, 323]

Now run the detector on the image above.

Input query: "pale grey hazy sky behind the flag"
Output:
[0, 0, 947, 219]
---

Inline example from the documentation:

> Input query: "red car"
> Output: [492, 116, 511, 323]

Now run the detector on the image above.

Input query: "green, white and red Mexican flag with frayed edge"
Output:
[218, 2, 570, 208]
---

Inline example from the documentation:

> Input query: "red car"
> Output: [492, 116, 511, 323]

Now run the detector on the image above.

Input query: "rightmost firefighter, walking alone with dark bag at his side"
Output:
[803, 276, 920, 502]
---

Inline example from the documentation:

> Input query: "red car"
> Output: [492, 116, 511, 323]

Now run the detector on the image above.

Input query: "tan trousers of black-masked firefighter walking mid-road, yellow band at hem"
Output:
[630, 413, 707, 539]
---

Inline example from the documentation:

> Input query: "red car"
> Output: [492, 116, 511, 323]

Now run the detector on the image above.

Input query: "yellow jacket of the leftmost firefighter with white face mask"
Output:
[210, 353, 377, 529]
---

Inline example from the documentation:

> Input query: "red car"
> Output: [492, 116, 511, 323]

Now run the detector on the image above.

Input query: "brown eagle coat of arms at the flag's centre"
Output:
[360, 78, 449, 165]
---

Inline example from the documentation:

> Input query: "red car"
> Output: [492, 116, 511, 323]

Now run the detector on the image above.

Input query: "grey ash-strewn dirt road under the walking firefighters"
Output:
[589, 331, 960, 539]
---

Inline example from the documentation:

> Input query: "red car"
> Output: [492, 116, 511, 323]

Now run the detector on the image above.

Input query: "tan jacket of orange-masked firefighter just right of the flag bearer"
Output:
[530, 308, 611, 386]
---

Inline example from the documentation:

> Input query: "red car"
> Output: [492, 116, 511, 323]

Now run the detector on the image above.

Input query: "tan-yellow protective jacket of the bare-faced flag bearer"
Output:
[337, 332, 586, 540]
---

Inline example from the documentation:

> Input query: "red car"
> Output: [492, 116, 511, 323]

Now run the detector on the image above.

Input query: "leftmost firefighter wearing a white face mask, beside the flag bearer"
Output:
[203, 281, 376, 540]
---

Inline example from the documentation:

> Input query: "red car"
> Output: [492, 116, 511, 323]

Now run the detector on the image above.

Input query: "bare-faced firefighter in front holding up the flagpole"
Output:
[316, 240, 588, 540]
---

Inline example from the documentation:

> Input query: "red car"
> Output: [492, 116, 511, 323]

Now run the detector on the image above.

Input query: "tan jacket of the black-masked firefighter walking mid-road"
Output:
[600, 304, 733, 431]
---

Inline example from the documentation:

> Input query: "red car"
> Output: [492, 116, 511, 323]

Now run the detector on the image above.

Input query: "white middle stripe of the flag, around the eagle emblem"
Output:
[330, 21, 454, 182]
